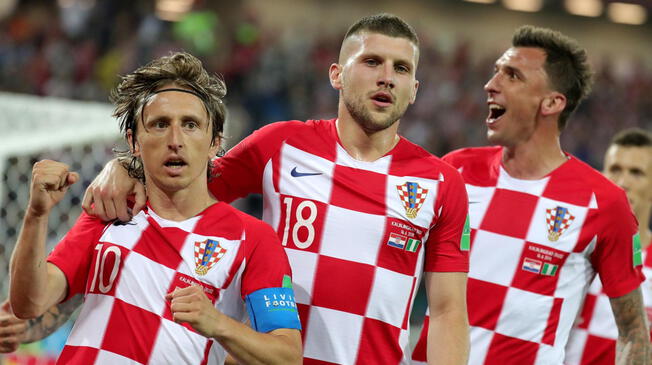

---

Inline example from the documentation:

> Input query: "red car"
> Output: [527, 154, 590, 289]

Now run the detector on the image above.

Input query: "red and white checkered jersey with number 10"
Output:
[48, 203, 290, 365]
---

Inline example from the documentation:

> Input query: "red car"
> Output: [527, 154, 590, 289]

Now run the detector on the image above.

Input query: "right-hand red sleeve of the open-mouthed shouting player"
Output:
[591, 191, 645, 298]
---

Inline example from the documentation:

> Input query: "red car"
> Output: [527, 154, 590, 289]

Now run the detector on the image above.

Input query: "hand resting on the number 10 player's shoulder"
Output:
[82, 158, 146, 222]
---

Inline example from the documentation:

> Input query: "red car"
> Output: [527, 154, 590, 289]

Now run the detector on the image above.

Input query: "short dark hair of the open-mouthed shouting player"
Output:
[512, 25, 593, 130]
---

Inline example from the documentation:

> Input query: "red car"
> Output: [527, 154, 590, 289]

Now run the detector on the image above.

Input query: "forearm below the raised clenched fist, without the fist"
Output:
[10, 209, 48, 318]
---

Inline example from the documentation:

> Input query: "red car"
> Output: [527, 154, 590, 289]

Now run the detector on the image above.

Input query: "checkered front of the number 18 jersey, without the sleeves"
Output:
[263, 131, 458, 364]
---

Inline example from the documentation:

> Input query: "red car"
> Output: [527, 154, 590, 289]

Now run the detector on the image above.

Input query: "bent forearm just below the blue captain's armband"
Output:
[213, 314, 302, 365]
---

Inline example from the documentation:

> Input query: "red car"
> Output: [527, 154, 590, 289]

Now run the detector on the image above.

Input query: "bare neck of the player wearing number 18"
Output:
[335, 117, 400, 162]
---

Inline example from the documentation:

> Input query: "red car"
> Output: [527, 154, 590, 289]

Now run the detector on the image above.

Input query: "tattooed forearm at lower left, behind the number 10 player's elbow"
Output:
[23, 294, 83, 343]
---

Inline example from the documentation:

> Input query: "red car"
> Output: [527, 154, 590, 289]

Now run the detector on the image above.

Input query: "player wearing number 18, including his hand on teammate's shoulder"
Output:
[14, 14, 468, 365]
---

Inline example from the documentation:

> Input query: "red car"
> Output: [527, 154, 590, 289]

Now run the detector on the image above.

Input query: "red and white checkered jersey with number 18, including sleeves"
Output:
[209, 120, 468, 365]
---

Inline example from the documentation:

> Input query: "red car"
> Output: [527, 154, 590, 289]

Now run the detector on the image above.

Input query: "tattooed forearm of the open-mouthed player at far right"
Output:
[609, 287, 650, 365]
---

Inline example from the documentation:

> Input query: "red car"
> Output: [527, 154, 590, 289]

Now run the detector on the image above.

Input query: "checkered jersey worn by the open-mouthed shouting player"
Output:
[414, 147, 643, 365]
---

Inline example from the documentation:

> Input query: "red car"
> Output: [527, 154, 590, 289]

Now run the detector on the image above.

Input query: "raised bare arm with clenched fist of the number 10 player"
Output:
[9, 160, 79, 319]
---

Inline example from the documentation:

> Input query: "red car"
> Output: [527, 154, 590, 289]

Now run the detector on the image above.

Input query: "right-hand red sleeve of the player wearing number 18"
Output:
[424, 165, 470, 272]
